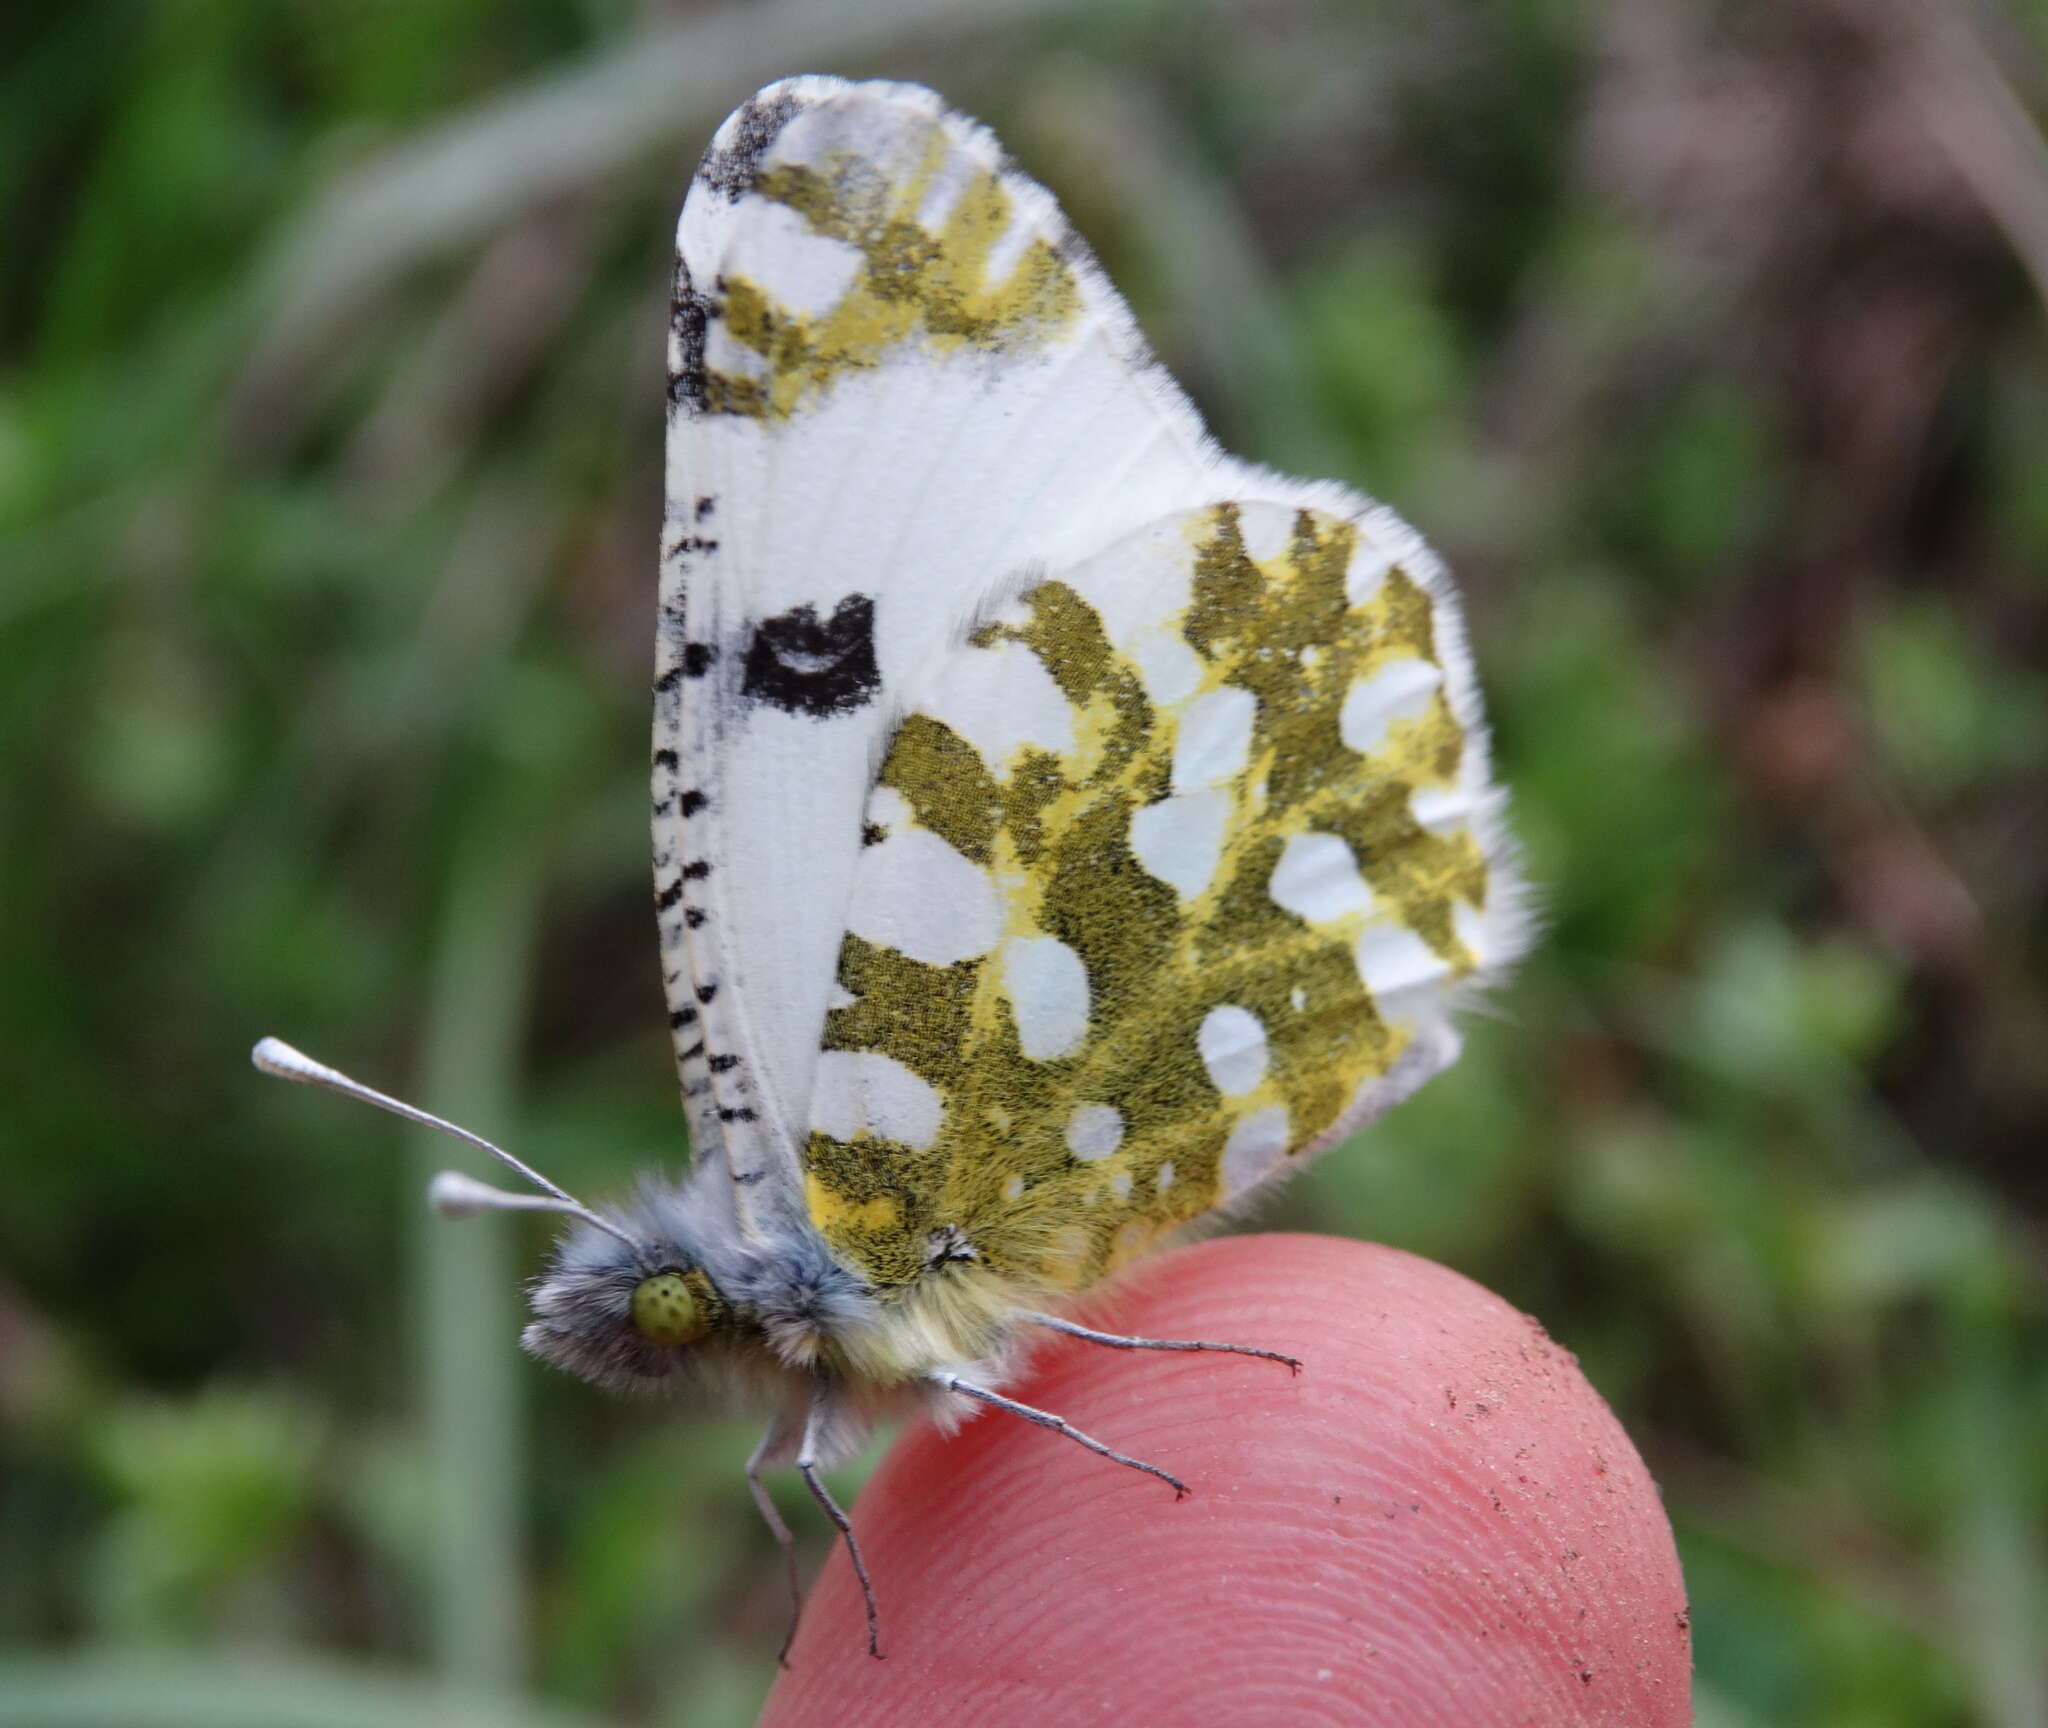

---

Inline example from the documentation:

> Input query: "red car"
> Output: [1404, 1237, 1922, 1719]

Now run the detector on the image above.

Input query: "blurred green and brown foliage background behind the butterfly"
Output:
[0, 0, 2048, 1728]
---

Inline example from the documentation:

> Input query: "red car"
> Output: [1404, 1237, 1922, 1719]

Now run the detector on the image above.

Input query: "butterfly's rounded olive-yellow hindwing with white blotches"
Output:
[805, 483, 1526, 1290]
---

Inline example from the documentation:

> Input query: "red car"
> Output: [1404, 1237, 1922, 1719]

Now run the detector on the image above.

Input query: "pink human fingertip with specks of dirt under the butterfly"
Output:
[762, 1235, 1692, 1728]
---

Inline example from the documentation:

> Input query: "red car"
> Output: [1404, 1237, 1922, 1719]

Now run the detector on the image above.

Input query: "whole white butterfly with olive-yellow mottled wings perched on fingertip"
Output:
[256, 78, 1530, 1654]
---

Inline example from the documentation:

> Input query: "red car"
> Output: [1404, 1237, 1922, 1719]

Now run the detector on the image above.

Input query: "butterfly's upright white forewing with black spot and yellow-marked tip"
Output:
[653, 78, 1225, 1220]
